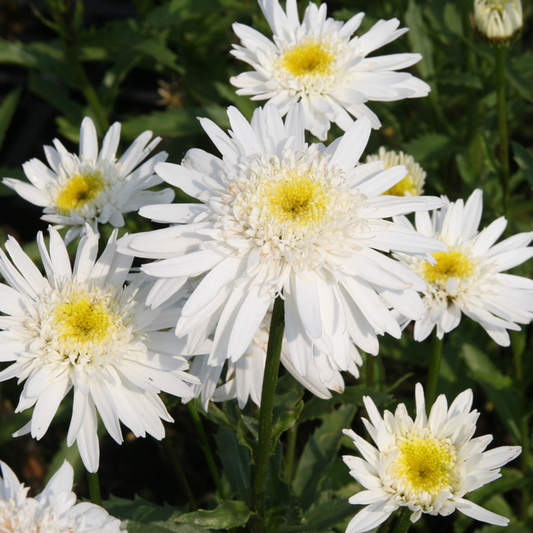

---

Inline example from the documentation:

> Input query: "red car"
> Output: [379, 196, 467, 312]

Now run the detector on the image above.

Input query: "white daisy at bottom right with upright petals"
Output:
[343, 384, 521, 533]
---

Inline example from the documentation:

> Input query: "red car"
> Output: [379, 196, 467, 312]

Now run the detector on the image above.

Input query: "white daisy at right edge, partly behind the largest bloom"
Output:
[395, 189, 533, 346]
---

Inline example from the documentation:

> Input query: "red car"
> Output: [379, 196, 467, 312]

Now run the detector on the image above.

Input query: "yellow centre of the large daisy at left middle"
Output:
[54, 294, 115, 346]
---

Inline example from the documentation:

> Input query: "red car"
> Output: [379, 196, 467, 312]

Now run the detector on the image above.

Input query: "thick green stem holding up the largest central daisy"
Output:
[252, 296, 285, 533]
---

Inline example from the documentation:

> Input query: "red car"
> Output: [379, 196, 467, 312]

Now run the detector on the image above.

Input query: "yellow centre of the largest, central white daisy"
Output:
[266, 173, 327, 225]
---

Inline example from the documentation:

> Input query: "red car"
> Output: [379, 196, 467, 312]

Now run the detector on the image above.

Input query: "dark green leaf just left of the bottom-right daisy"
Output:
[293, 405, 357, 509]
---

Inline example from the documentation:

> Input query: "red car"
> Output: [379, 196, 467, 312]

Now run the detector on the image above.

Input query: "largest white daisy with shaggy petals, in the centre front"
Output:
[119, 105, 446, 384]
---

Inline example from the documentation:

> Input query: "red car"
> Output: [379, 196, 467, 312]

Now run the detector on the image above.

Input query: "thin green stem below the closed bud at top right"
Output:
[494, 46, 509, 218]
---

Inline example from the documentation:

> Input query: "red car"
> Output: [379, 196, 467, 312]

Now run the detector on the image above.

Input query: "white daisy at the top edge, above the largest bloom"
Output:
[230, 0, 430, 140]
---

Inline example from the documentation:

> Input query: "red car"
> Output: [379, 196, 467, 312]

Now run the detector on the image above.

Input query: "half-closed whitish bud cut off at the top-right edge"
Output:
[474, 0, 523, 41]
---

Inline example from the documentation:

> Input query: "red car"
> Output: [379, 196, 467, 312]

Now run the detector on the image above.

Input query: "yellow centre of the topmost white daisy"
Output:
[282, 40, 334, 77]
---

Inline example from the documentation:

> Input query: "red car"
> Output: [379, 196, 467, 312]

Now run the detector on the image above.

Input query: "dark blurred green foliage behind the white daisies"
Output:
[0, 0, 533, 533]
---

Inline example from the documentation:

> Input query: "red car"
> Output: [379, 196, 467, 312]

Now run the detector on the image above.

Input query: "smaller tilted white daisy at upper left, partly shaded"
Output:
[3, 117, 174, 243]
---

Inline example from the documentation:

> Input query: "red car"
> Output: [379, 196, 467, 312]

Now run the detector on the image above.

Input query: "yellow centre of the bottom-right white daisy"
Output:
[393, 436, 456, 496]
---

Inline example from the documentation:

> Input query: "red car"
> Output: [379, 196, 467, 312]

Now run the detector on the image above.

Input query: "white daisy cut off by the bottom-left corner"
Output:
[0, 461, 123, 533]
